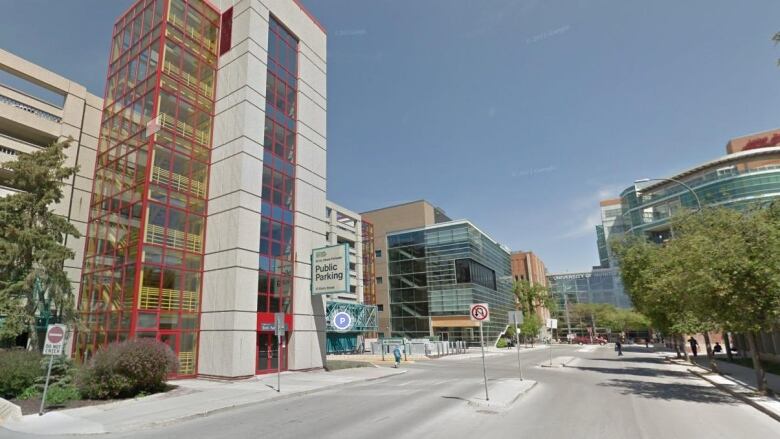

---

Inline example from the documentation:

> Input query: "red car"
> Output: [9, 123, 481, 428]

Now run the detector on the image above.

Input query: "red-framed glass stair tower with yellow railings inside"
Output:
[76, 0, 219, 376]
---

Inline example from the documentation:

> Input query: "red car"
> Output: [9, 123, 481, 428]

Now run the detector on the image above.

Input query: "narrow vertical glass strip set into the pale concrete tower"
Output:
[257, 17, 298, 373]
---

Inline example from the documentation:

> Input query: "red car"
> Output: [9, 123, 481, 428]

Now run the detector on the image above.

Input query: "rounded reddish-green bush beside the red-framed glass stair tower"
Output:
[78, 339, 178, 399]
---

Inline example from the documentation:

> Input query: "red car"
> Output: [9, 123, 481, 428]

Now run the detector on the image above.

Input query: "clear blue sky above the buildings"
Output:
[0, 0, 780, 272]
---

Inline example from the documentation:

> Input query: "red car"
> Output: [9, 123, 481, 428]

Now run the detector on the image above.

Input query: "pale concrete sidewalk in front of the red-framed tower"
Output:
[0, 367, 406, 436]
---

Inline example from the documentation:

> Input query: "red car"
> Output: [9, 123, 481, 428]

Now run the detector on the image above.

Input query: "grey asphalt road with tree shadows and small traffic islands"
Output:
[3, 346, 780, 439]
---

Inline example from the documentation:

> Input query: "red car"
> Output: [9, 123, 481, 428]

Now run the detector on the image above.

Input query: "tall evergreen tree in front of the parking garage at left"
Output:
[0, 141, 79, 349]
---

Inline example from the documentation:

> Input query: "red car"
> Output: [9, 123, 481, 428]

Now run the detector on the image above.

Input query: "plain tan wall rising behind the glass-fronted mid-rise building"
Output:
[361, 200, 449, 337]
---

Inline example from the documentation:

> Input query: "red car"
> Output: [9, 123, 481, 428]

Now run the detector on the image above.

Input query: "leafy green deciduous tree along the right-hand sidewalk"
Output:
[614, 204, 780, 393]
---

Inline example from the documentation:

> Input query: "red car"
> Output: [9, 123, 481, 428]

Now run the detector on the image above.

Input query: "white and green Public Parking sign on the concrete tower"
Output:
[311, 244, 349, 294]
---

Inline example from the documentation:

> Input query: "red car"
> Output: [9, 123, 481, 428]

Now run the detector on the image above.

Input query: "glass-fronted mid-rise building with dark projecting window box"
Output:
[387, 221, 515, 344]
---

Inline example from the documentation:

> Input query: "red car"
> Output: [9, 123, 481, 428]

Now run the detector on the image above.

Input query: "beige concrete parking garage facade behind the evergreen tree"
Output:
[0, 49, 103, 300]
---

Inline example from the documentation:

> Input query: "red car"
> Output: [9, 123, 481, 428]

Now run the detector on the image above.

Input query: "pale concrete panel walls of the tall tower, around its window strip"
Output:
[198, 0, 327, 378]
